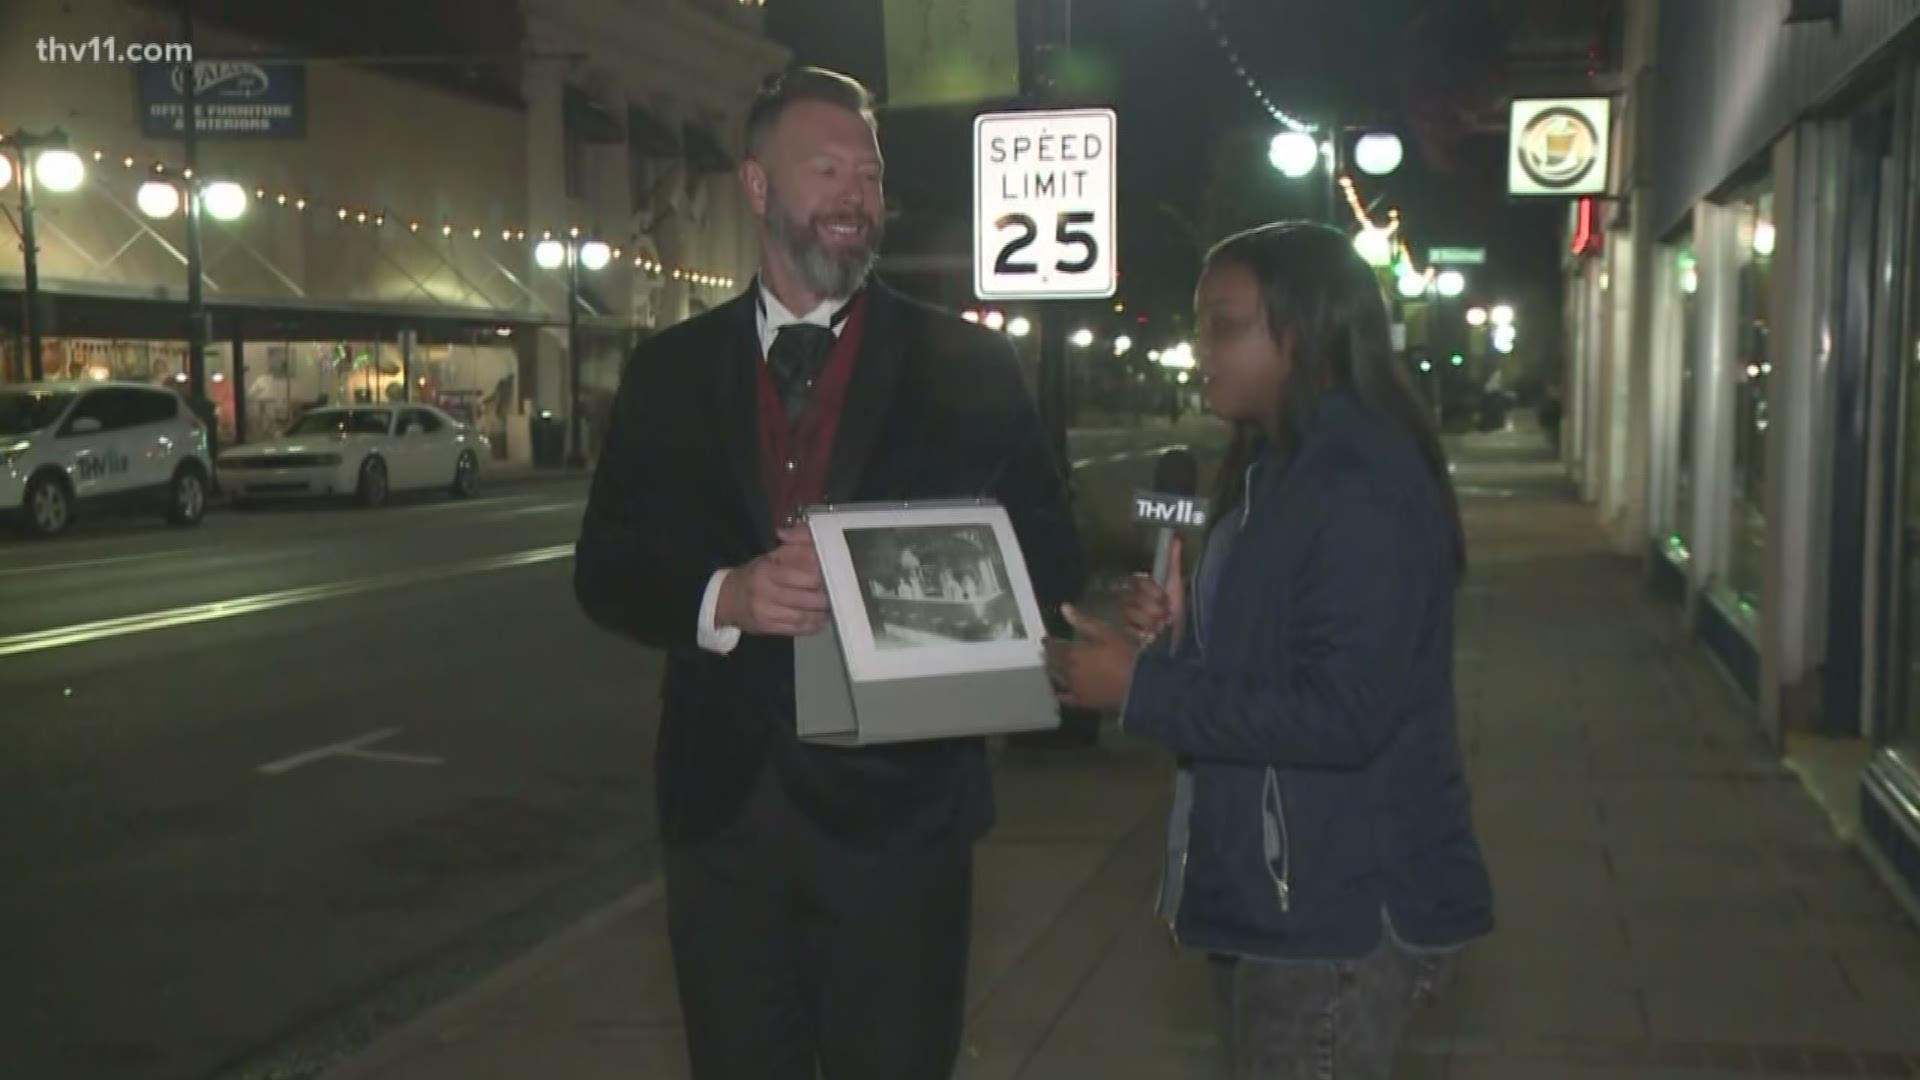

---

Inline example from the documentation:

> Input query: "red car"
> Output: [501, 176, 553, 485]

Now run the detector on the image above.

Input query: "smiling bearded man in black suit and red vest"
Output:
[574, 69, 1083, 1080]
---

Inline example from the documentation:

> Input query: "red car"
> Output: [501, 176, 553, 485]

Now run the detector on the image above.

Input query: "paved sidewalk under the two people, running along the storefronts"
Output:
[328, 424, 1920, 1080]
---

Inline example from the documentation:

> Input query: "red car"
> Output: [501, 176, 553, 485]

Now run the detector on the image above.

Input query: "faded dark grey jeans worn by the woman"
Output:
[1213, 928, 1459, 1080]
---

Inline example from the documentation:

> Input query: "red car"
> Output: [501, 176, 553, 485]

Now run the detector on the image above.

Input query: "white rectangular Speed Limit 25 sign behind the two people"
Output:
[973, 110, 1119, 300]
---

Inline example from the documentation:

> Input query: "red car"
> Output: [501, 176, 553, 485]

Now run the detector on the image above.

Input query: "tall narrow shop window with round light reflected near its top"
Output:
[1726, 190, 1774, 621]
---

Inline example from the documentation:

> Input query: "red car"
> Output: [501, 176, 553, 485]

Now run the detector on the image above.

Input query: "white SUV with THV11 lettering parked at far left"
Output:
[0, 382, 213, 536]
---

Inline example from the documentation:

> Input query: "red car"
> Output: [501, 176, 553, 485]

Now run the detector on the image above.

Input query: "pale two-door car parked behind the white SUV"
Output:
[221, 405, 492, 505]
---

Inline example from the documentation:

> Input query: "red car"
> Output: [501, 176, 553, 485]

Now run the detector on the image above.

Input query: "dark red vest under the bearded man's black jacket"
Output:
[760, 294, 866, 527]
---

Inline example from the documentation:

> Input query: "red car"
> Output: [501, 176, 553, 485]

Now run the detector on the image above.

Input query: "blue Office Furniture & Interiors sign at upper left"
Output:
[136, 60, 307, 138]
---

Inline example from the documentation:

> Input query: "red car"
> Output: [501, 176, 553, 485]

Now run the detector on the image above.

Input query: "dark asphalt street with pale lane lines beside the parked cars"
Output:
[0, 420, 1198, 1080]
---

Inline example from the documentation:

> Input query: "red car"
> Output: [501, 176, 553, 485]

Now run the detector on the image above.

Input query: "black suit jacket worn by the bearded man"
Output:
[574, 281, 1085, 847]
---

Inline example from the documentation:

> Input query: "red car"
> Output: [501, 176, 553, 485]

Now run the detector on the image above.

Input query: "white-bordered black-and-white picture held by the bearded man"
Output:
[806, 502, 1046, 682]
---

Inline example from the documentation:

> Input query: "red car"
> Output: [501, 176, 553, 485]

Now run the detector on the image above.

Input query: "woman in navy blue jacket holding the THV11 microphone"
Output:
[1048, 223, 1494, 1080]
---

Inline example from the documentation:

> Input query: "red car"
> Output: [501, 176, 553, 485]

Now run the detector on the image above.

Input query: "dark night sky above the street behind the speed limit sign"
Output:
[768, 0, 1565, 345]
